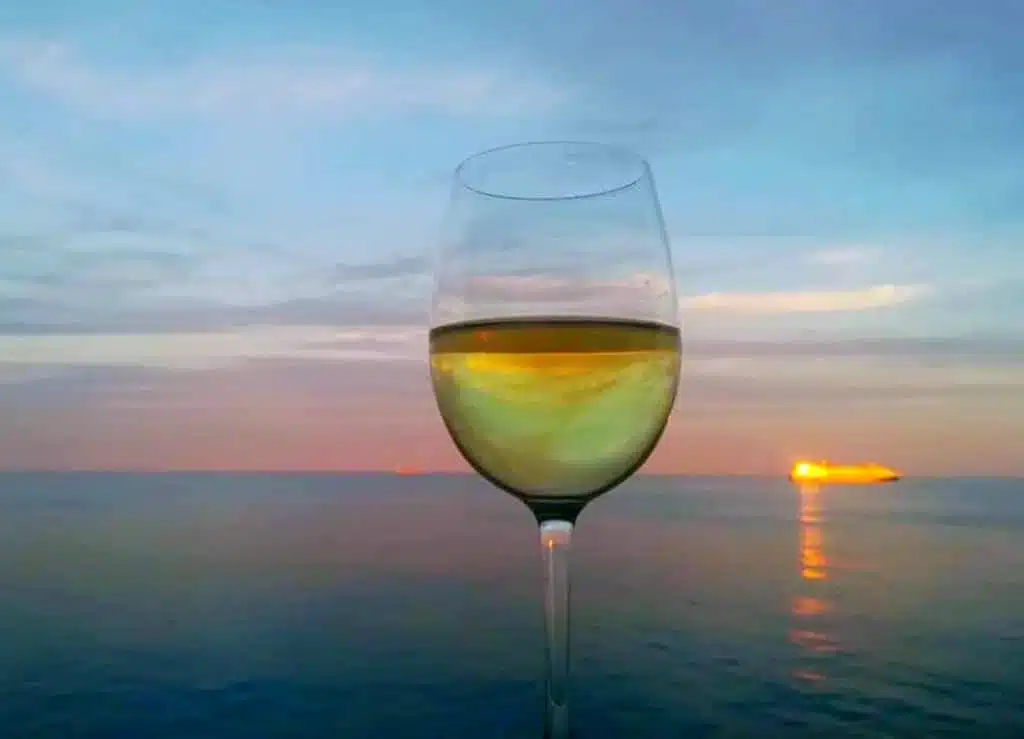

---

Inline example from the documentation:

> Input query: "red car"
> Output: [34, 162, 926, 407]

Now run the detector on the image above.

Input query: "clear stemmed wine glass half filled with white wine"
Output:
[430, 141, 680, 739]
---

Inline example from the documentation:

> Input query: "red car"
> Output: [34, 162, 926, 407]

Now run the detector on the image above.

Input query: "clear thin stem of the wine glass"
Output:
[541, 521, 572, 739]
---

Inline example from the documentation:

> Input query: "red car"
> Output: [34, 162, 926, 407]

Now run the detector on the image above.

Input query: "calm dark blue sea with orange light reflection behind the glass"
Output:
[0, 475, 1024, 739]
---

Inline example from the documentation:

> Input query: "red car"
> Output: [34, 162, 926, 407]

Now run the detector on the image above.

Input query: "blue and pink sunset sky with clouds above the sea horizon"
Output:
[0, 0, 1024, 476]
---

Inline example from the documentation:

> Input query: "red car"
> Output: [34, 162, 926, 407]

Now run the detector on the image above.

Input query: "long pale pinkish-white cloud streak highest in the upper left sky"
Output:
[0, 39, 563, 121]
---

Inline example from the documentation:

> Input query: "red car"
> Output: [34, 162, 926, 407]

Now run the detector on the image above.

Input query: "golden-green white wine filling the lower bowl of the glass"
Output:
[430, 318, 679, 501]
